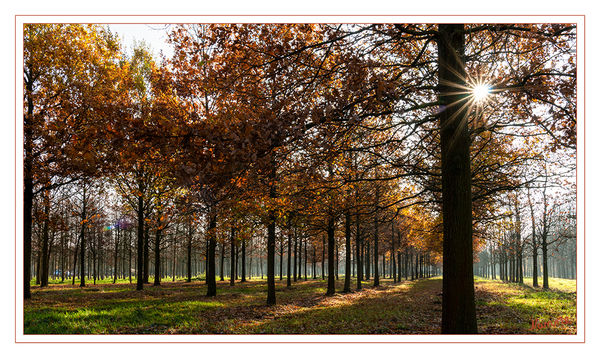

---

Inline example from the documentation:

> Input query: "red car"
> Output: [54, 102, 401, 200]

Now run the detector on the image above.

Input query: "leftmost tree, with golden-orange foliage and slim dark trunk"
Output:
[23, 24, 121, 299]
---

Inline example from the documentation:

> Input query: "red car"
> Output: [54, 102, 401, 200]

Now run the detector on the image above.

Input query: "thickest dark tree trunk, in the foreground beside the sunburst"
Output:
[438, 24, 477, 334]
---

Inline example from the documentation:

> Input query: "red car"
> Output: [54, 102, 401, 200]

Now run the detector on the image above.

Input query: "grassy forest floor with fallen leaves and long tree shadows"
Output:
[24, 277, 577, 334]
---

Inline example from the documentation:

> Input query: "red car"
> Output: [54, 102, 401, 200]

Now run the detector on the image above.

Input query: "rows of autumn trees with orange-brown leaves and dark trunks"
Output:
[24, 24, 576, 333]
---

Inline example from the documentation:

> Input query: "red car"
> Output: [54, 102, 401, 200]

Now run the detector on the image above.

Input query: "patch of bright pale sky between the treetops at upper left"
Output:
[107, 24, 173, 59]
